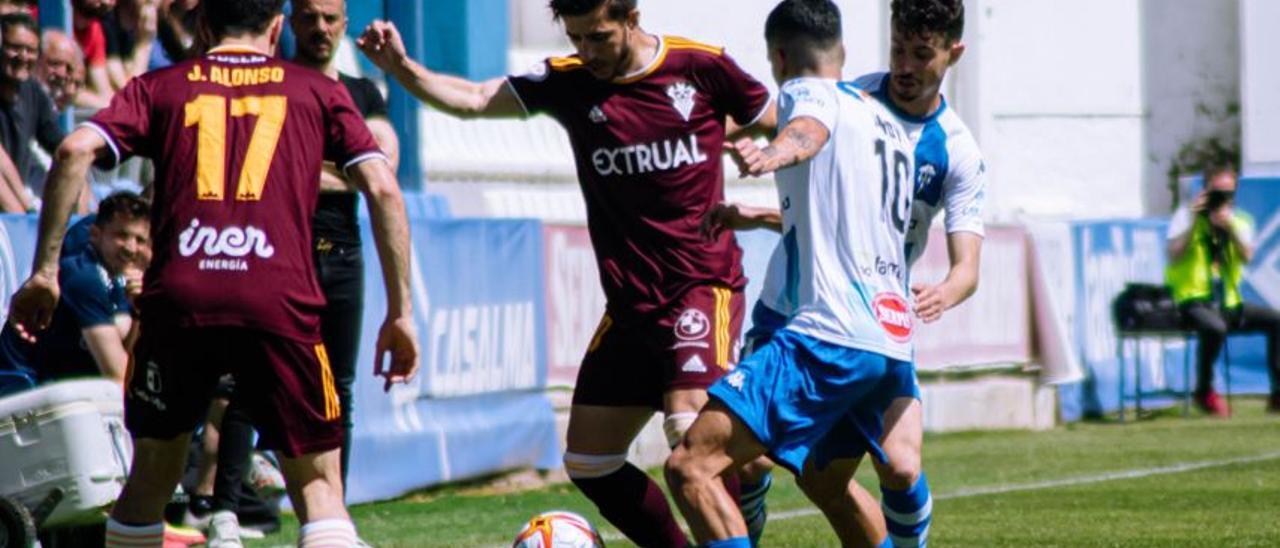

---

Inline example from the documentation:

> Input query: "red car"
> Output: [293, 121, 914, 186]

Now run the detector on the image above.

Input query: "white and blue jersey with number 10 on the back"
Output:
[762, 78, 915, 361]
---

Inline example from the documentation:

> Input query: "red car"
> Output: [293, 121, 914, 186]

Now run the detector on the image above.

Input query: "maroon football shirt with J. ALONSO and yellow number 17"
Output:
[86, 47, 381, 341]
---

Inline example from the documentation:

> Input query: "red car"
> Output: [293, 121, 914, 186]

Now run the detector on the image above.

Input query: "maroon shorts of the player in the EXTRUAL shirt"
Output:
[573, 286, 745, 410]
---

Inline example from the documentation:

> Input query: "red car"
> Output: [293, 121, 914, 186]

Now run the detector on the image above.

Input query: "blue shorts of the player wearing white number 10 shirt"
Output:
[708, 329, 920, 475]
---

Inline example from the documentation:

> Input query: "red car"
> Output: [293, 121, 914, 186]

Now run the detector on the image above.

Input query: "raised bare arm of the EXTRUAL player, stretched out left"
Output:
[356, 20, 525, 118]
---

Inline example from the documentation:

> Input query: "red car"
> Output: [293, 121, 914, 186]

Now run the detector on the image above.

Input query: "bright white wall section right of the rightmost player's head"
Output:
[960, 0, 1143, 218]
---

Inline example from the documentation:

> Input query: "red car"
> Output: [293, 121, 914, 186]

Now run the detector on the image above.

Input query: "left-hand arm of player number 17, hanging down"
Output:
[9, 128, 106, 341]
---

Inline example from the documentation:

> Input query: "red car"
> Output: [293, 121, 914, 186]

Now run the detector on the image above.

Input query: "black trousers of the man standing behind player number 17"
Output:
[214, 239, 372, 511]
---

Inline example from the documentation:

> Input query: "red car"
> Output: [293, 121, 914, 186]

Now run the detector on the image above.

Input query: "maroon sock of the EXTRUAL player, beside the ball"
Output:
[573, 462, 689, 548]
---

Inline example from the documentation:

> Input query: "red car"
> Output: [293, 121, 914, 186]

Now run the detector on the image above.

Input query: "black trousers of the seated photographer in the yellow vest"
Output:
[1181, 301, 1280, 396]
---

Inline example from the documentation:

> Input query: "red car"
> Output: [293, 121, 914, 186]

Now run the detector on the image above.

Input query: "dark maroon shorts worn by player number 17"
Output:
[124, 323, 343, 457]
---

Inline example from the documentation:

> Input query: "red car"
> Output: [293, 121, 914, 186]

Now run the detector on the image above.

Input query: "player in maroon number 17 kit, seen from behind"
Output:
[14, 0, 417, 545]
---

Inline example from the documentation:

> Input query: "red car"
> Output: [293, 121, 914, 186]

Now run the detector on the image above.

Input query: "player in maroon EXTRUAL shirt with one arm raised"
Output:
[361, 0, 772, 545]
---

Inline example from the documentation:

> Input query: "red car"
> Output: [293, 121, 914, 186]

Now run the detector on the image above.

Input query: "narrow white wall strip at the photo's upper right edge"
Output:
[1240, 0, 1280, 175]
